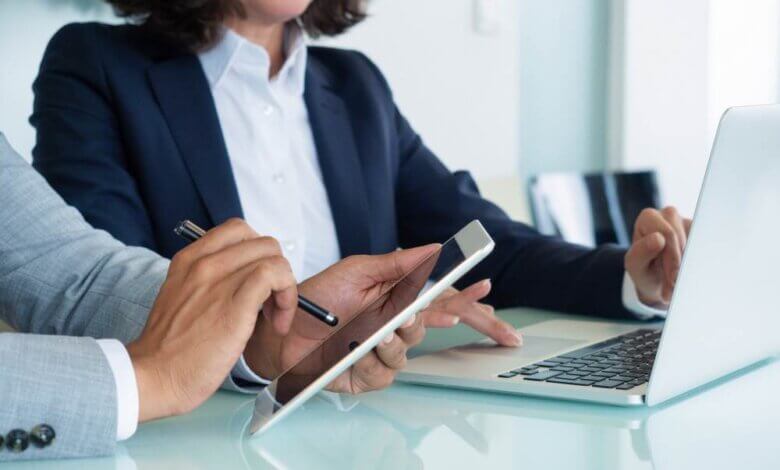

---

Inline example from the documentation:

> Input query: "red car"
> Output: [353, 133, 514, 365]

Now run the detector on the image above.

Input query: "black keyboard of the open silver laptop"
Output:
[498, 329, 661, 390]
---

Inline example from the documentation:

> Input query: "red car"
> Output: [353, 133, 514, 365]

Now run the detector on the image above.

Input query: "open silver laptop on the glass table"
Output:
[399, 105, 780, 406]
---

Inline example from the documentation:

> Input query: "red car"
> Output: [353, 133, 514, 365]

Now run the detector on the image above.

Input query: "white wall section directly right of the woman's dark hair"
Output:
[314, 0, 520, 179]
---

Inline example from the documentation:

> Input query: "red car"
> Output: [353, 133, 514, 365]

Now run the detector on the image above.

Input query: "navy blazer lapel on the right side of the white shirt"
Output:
[304, 59, 372, 257]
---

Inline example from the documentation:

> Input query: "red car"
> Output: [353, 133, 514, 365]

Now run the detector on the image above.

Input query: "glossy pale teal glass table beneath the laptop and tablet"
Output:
[3, 309, 780, 470]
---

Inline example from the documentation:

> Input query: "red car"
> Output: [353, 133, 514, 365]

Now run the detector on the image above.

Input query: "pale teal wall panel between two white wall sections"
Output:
[519, 0, 609, 176]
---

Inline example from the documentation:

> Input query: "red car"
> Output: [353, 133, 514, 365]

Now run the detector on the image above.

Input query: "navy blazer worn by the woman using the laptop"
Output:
[30, 23, 629, 317]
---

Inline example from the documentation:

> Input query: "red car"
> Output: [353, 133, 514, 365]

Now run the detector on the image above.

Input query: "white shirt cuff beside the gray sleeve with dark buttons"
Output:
[97, 339, 139, 441]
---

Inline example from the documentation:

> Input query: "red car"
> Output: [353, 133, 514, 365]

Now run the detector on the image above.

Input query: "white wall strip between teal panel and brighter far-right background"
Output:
[610, 0, 709, 214]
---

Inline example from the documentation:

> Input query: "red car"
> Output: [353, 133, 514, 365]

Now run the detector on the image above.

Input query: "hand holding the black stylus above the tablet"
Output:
[127, 220, 297, 421]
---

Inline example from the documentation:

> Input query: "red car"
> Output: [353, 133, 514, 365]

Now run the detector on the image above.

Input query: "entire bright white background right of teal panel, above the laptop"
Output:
[609, 0, 780, 215]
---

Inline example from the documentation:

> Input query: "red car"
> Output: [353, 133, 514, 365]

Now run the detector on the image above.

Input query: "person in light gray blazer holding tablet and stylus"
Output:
[0, 133, 432, 461]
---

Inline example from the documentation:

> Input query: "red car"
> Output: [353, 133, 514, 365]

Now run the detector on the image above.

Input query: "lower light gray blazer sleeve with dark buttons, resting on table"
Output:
[0, 333, 116, 462]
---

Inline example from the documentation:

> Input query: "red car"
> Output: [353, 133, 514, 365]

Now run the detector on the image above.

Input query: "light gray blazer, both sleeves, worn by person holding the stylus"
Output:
[0, 134, 168, 460]
